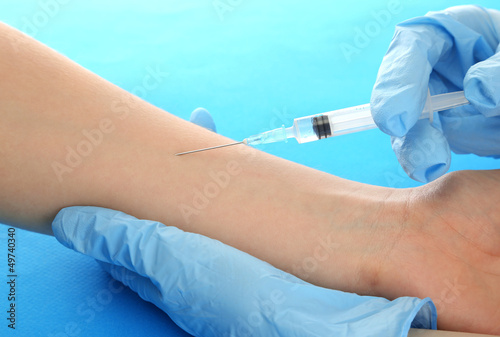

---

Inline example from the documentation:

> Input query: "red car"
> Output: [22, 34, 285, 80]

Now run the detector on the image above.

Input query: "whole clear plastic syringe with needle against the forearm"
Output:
[176, 91, 469, 156]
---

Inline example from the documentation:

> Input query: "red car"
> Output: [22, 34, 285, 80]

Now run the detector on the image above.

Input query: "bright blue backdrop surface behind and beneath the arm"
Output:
[0, 0, 500, 337]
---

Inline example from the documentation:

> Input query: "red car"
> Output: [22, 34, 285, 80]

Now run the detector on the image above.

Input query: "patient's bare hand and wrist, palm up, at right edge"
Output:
[377, 170, 500, 334]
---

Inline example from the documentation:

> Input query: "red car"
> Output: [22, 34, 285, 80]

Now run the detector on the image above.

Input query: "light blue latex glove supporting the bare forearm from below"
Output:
[52, 207, 436, 337]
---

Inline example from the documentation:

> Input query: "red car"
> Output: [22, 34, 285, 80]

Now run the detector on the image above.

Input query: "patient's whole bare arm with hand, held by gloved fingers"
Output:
[0, 25, 500, 332]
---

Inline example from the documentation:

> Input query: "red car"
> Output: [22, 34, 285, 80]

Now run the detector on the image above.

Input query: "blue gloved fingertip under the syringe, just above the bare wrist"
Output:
[391, 120, 451, 183]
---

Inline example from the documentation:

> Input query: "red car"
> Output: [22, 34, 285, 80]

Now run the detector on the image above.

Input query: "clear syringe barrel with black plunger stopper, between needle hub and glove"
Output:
[294, 104, 377, 143]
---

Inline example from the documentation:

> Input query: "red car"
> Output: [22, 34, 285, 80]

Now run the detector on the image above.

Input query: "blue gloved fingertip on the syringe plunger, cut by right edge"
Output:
[464, 46, 500, 117]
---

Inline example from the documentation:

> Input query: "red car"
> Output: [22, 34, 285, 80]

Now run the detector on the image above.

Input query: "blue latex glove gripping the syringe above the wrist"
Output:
[371, 6, 500, 182]
